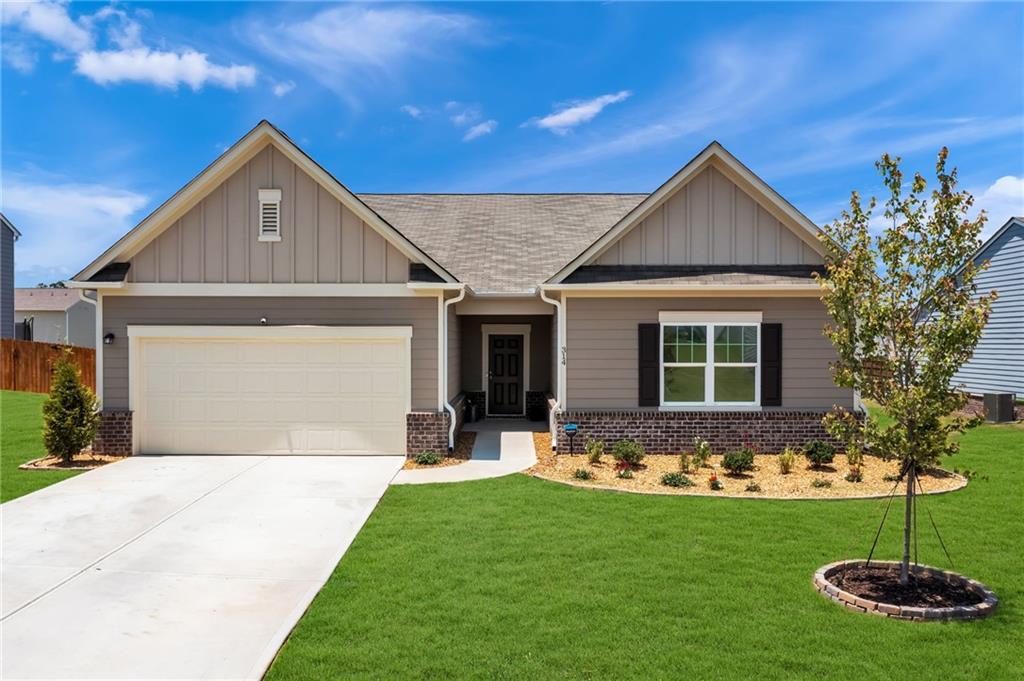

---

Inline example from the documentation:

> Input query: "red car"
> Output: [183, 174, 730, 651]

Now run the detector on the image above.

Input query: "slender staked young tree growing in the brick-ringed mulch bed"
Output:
[818, 147, 995, 585]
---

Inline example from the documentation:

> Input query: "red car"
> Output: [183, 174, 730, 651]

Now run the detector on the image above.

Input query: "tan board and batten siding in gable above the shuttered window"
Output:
[590, 166, 823, 265]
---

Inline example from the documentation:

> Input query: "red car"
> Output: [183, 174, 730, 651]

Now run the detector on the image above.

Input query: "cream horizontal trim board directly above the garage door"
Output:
[128, 324, 413, 340]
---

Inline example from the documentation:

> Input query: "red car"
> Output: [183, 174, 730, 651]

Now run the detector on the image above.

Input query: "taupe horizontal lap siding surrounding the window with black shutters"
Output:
[566, 297, 853, 410]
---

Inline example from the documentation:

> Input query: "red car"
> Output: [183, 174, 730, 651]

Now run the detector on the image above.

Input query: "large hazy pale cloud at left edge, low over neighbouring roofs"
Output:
[3, 172, 148, 286]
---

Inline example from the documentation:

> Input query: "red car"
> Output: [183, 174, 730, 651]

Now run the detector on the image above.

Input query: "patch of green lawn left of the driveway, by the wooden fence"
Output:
[0, 390, 81, 502]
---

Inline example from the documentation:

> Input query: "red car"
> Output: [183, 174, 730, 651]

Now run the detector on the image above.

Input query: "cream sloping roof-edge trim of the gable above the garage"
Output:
[73, 120, 455, 283]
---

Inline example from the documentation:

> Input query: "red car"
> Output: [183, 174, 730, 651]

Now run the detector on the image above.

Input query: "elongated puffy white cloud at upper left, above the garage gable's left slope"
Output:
[75, 47, 256, 90]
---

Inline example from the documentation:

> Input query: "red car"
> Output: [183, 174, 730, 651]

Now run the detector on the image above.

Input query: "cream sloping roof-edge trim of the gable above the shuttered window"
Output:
[548, 141, 825, 284]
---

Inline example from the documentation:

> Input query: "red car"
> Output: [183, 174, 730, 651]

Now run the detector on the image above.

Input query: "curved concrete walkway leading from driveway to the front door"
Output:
[392, 419, 546, 484]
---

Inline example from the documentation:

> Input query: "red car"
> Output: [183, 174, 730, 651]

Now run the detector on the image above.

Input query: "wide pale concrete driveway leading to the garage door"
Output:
[0, 457, 402, 681]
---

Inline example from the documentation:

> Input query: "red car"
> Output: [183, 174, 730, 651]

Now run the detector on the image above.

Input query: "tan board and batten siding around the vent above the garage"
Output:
[128, 145, 409, 284]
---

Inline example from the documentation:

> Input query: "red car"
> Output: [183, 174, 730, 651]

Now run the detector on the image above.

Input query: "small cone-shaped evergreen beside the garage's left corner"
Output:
[43, 350, 99, 464]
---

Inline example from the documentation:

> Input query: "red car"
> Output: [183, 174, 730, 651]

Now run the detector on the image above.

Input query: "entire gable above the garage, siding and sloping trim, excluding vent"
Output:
[75, 121, 455, 284]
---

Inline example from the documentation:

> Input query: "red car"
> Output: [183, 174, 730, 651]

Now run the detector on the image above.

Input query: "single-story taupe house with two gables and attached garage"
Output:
[71, 121, 855, 454]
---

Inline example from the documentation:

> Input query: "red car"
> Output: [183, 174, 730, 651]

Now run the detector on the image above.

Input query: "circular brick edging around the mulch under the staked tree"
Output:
[814, 560, 999, 621]
